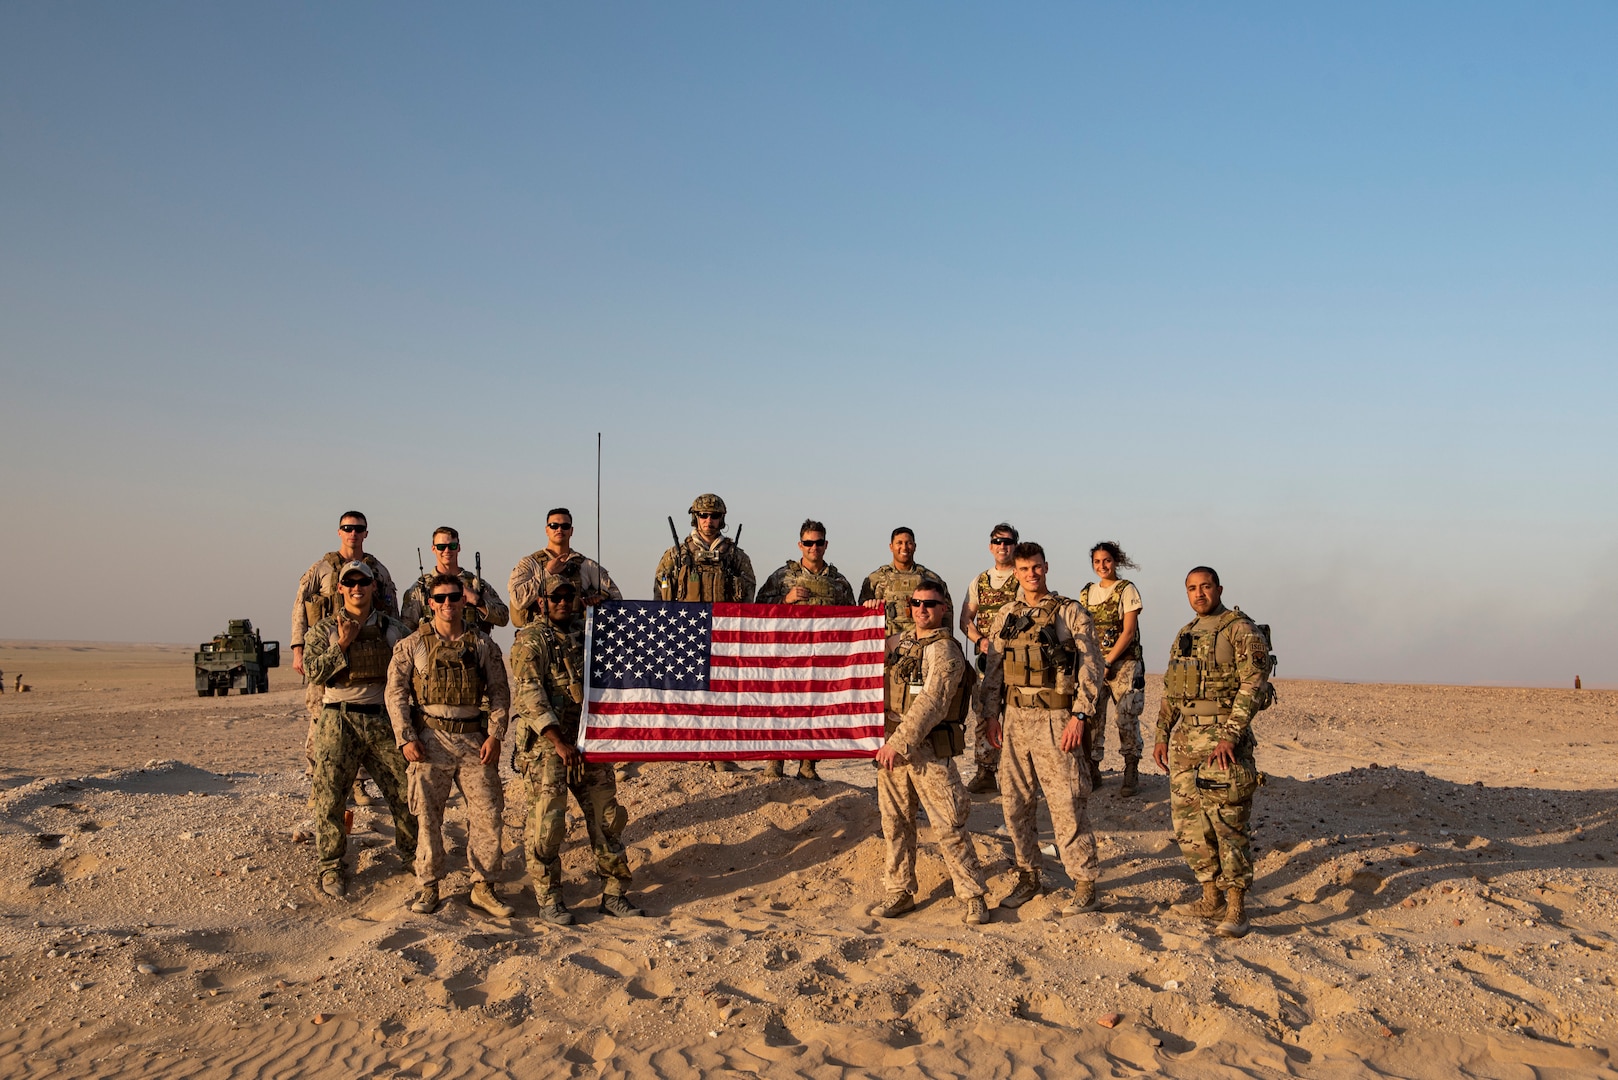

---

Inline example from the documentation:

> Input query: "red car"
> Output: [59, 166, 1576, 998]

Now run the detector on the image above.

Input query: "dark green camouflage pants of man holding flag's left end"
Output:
[526, 735, 629, 899]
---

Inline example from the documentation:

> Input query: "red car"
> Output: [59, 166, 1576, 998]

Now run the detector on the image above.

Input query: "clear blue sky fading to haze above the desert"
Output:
[0, 3, 1618, 685]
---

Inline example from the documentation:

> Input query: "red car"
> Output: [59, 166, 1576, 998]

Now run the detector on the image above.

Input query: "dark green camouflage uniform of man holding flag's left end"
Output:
[511, 617, 629, 907]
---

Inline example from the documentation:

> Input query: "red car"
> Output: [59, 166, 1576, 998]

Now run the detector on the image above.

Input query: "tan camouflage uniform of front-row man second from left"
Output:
[387, 623, 511, 886]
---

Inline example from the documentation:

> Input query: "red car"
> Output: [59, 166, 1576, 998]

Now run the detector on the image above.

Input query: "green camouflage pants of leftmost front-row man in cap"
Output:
[309, 704, 416, 873]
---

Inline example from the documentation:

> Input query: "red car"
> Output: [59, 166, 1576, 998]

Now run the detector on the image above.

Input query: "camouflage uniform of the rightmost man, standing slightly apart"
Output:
[1157, 604, 1273, 891]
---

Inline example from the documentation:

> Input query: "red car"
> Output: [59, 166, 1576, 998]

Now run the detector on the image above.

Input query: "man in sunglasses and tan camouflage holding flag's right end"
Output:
[874, 581, 989, 926]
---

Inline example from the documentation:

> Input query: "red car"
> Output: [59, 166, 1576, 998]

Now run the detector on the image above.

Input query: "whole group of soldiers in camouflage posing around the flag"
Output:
[291, 494, 1273, 936]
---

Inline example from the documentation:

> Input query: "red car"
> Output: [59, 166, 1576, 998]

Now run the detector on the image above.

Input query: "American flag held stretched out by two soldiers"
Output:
[579, 601, 885, 761]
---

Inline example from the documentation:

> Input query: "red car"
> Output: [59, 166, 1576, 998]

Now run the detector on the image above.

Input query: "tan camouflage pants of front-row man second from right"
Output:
[1000, 704, 1100, 881]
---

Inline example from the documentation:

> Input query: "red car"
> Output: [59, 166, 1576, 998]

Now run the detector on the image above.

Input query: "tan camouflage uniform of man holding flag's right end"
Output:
[877, 628, 984, 900]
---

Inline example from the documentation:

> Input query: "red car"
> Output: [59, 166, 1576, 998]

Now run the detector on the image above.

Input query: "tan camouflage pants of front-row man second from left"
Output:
[408, 724, 505, 886]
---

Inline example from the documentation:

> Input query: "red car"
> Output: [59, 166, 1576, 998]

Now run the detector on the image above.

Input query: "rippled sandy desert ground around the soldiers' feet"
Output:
[0, 641, 1618, 1078]
